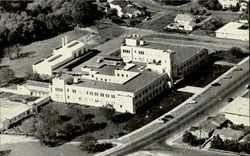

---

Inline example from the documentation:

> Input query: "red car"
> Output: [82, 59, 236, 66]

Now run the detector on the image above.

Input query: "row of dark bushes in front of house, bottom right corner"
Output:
[211, 136, 250, 154]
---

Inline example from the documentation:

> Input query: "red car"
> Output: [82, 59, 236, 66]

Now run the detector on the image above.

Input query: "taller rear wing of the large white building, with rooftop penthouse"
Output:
[121, 35, 208, 80]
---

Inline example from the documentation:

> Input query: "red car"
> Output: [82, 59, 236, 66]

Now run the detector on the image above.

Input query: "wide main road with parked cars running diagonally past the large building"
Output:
[95, 60, 249, 155]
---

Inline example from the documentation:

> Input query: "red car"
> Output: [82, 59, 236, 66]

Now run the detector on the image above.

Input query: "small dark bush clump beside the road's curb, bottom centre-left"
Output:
[80, 134, 113, 153]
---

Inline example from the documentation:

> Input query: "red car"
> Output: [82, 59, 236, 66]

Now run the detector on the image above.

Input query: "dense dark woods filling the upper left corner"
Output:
[0, 0, 100, 57]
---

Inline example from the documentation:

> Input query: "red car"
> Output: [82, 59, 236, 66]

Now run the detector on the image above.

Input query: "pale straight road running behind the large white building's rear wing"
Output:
[122, 27, 249, 51]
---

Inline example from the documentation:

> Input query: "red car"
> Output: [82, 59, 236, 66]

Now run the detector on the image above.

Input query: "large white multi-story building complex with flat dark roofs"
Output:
[34, 35, 208, 113]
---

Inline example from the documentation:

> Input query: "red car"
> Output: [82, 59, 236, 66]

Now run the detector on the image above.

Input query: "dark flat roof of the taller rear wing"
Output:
[124, 40, 203, 64]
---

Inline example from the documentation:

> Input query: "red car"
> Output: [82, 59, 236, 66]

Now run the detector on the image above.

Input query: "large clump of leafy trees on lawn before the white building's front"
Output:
[34, 105, 106, 146]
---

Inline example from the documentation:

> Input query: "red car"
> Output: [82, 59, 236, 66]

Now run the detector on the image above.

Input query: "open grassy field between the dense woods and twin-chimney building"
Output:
[0, 30, 88, 77]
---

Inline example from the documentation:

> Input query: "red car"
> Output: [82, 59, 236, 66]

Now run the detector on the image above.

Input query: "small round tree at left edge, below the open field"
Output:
[0, 67, 15, 83]
